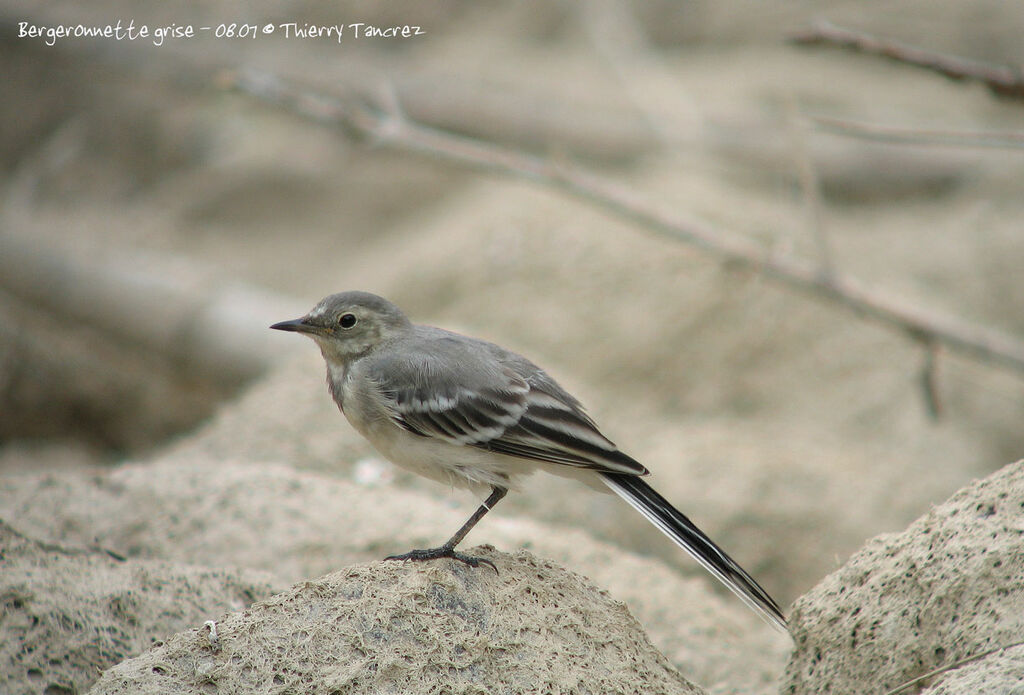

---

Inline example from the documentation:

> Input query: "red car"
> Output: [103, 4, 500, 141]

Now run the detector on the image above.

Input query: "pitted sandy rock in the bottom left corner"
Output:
[0, 522, 280, 695]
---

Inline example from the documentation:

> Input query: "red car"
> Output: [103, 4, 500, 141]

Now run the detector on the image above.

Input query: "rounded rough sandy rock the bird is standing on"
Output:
[89, 547, 703, 695]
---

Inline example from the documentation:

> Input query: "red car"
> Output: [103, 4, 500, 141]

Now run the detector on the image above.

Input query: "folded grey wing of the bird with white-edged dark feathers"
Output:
[374, 335, 647, 475]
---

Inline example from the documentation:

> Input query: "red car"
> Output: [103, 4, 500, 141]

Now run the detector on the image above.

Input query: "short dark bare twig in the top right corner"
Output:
[792, 19, 1024, 99]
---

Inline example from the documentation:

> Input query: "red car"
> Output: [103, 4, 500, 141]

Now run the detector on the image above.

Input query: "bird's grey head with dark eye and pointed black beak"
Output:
[270, 292, 412, 364]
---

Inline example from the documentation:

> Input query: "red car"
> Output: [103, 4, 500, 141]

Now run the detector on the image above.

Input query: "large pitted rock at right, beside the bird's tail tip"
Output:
[782, 462, 1024, 695]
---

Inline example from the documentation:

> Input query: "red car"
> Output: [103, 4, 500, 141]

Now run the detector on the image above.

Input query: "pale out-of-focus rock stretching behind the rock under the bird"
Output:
[0, 458, 791, 693]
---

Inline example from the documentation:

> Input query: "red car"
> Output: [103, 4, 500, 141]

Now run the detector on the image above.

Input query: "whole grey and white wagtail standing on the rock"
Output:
[270, 292, 785, 629]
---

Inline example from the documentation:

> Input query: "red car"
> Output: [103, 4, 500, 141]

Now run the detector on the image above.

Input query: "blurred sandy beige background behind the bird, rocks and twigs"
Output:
[0, 1, 1024, 691]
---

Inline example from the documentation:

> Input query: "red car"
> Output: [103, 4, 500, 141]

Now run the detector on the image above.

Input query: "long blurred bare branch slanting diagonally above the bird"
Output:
[223, 72, 1024, 372]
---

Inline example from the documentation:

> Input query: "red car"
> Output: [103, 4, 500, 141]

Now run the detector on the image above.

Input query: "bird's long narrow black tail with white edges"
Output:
[601, 473, 786, 631]
